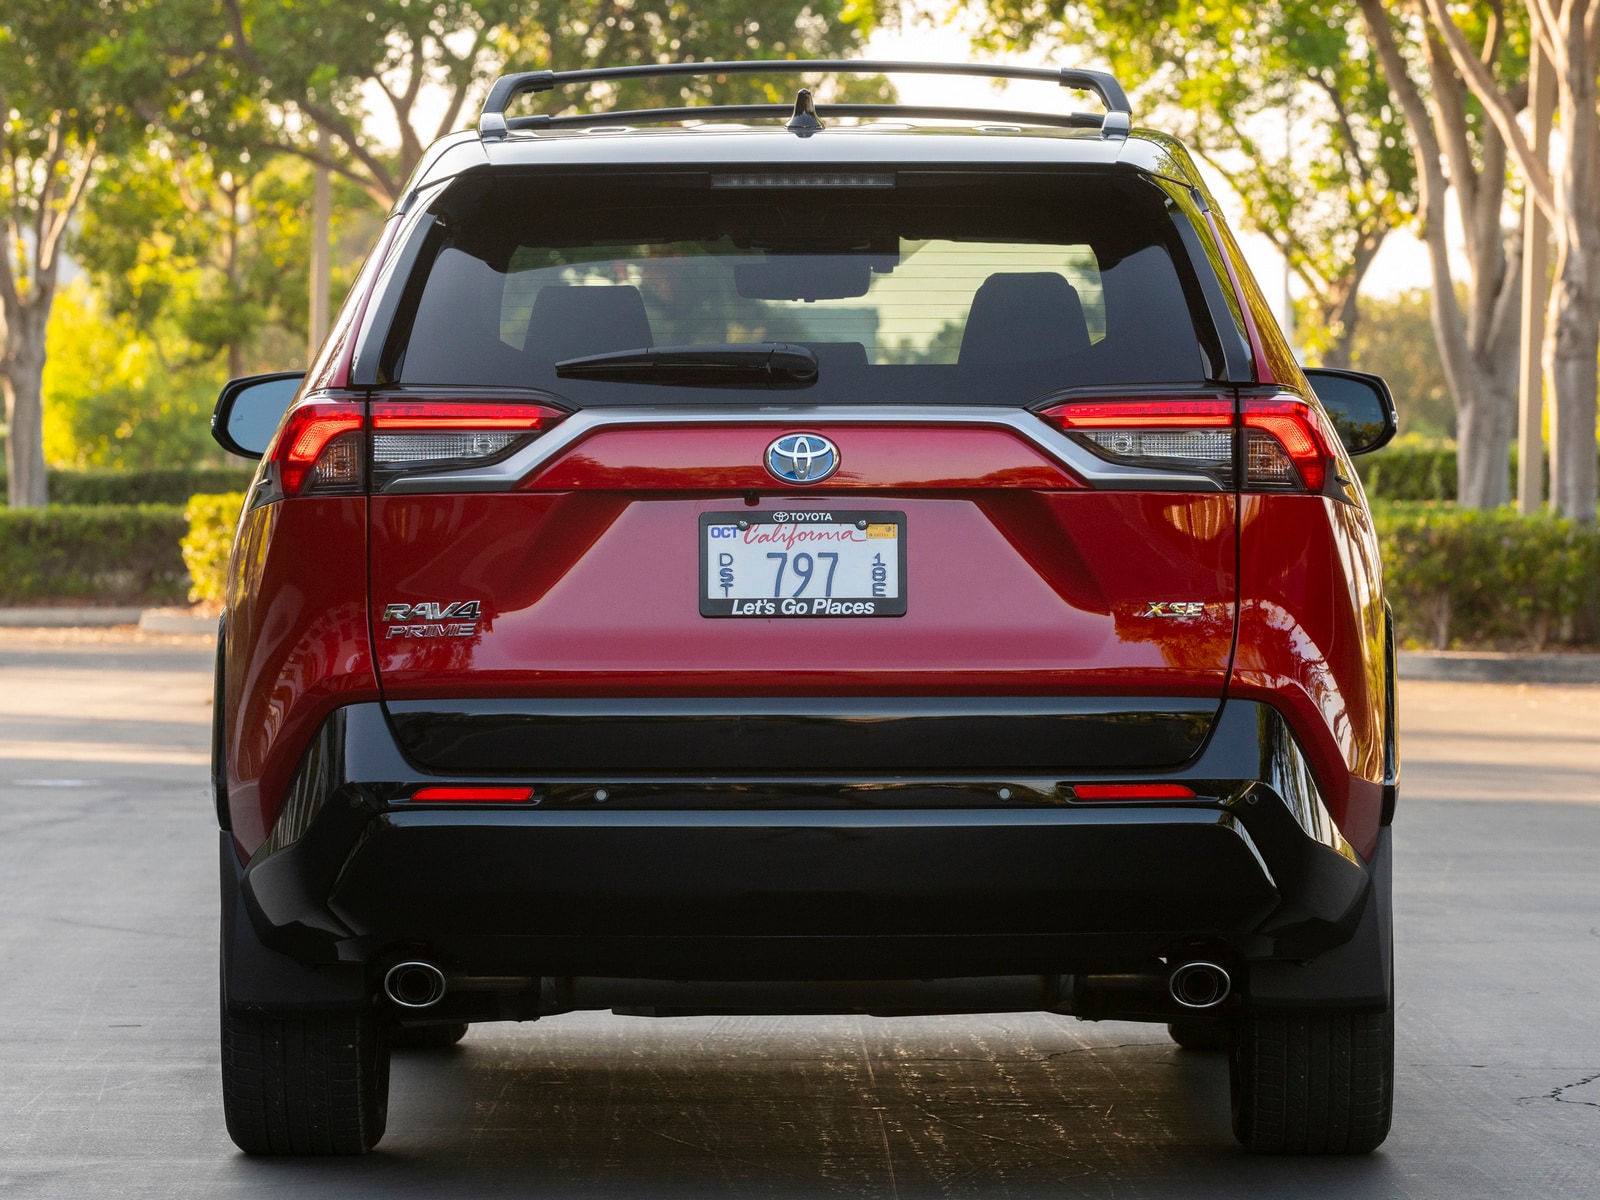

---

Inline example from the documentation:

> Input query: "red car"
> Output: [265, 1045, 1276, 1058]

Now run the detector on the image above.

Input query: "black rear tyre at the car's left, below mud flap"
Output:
[222, 1013, 389, 1155]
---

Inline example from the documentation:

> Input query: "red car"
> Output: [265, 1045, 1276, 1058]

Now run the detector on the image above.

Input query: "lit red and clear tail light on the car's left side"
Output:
[262, 400, 566, 502]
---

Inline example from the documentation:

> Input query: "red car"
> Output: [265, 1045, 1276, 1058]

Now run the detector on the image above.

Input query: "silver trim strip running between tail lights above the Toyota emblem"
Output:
[384, 405, 1224, 496]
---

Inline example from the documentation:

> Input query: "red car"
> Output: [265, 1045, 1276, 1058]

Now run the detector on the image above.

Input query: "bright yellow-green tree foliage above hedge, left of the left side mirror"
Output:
[43, 136, 381, 469]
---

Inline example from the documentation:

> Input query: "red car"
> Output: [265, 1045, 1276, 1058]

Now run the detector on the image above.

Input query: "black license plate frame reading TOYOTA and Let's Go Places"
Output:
[698, 509, 907, 621]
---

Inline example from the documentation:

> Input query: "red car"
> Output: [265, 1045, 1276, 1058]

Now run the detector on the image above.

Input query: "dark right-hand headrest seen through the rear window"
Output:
[958, 270, 1090, 363]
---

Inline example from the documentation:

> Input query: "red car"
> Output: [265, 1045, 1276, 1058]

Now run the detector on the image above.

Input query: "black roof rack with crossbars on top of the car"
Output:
[478, 59, 1133, 141]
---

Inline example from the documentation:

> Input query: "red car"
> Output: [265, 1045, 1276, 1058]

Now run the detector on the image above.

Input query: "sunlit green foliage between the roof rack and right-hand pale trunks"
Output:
[984, 0, 1414, 363]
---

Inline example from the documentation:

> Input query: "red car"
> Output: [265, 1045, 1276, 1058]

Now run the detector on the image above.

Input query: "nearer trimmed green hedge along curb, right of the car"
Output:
[1373, 504, 1600, 650]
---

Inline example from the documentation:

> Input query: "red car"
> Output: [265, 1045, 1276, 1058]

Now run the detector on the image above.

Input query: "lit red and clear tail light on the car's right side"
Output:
[1042, 395, 1336, 491]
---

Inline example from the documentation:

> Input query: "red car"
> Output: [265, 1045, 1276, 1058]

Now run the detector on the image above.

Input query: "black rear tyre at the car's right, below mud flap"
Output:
[1230, 1005, 1395, 1154]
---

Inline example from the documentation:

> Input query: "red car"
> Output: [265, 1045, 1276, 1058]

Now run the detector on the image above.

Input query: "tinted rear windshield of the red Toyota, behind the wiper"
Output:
[384, 171, 1224, 406]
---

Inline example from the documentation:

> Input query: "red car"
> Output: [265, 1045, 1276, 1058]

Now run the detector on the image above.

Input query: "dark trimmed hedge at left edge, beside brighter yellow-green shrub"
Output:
[0, 504, 189, 605]
